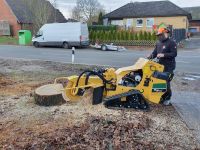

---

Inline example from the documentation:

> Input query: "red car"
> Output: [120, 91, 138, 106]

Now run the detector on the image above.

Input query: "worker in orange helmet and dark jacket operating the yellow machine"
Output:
[148, 28, 177, 105]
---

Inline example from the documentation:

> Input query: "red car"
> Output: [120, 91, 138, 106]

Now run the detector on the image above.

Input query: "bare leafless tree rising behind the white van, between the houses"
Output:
[72, 0, 104, 25]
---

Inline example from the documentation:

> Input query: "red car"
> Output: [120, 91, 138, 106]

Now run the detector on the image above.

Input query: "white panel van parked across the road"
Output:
[32, 22, 89, 48]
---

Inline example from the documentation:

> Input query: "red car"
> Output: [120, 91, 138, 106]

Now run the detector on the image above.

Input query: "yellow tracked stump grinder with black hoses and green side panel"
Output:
[35, 58, 170, 110]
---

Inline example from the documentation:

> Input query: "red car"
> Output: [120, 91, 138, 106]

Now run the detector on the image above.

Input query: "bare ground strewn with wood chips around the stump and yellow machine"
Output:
[0, 60, 200, 149]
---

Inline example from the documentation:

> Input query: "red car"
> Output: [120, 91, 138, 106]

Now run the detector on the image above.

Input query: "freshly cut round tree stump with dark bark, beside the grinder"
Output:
[34, 84, 66, 106]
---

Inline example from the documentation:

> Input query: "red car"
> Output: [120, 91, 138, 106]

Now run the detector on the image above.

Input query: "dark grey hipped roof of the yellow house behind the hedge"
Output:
[104, 1, 191, 19]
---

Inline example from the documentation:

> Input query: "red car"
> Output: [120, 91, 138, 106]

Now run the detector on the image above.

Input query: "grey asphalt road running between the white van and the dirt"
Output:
[0, 45, 200, 73]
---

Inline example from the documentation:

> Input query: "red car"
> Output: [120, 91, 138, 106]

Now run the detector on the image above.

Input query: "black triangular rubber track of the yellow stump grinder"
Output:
[104, 90, 149, 111]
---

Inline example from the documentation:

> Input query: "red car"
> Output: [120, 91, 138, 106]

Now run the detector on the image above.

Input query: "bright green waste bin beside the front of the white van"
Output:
[18, 30, 32, 45]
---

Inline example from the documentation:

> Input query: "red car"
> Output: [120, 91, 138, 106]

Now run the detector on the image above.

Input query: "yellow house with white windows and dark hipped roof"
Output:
[103, 1, 191, 31]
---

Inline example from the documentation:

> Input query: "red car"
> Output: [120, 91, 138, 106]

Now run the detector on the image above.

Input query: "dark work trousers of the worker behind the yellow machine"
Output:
[161, 67, 174, 102]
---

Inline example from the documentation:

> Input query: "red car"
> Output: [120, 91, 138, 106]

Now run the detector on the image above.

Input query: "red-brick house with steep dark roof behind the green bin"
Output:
[0, 0, 66, 36]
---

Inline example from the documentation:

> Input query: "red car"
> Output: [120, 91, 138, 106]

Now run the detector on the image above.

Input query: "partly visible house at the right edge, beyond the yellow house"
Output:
[183, 7, 200, 33]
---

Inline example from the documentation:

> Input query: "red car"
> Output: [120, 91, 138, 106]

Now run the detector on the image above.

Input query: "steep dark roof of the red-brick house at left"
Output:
[5, 0, 66, 23]
